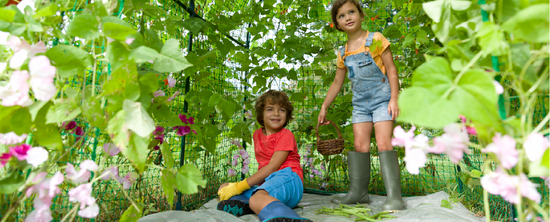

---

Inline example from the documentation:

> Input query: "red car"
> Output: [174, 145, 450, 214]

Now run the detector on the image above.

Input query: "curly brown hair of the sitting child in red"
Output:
[254, 90, 294, 127]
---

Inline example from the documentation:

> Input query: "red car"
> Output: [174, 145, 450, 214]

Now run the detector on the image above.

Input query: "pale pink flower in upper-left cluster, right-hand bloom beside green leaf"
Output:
[29, 56, 57, 101]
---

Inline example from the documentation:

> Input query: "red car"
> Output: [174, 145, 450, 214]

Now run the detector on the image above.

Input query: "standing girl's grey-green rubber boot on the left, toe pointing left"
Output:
[330, 151, 370, 204]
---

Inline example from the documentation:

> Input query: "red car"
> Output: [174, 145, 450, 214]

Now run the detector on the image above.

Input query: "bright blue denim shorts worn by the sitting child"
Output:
[240, 167, 304, 208]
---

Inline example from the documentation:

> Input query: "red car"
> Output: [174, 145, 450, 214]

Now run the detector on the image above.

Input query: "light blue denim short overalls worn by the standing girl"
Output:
[340, 32, 392, 123]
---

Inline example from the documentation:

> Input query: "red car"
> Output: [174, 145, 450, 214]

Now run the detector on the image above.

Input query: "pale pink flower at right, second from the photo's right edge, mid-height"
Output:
[481, 133, 518, 169]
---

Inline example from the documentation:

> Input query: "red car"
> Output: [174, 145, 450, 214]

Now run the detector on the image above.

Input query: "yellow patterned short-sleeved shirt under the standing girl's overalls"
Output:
[336, 31, 390, 75]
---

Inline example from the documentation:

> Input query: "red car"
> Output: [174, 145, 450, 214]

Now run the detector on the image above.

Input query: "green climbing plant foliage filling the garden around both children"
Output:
[0, 0, 550, 221]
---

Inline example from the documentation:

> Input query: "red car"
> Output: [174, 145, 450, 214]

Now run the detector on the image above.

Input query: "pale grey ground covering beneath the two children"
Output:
[138, 191, 485, 222]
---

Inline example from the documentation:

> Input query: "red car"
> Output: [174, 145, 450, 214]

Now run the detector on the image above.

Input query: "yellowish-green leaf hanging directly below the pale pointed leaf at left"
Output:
[121, 134, 149, 174]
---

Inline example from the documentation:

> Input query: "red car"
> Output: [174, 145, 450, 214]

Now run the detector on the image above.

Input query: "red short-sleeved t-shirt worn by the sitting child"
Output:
[253, 128, 304, 182]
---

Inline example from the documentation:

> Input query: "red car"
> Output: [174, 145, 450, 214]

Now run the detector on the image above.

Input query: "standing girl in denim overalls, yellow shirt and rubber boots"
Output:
[318, 0, 405, 211]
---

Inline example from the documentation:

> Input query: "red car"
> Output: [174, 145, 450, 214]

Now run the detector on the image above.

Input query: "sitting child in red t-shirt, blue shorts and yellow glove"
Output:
[218, 90, 311, 222]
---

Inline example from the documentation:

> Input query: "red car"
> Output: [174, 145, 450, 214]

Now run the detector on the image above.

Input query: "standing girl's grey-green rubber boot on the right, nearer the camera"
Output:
[378, 150, 405, 211]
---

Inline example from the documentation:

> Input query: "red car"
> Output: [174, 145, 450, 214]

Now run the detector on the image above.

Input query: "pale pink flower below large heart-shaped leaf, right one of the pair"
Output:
[428, 123, 470, 164]
